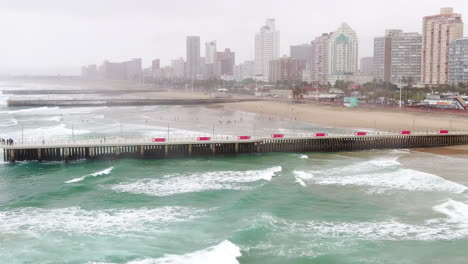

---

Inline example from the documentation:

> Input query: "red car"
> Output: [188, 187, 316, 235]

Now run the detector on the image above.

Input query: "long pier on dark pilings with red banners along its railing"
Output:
[0, 130, 468, 162]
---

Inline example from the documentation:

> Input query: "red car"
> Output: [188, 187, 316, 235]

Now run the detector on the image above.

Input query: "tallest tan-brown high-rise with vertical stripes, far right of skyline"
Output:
[421, 8, 463, 84]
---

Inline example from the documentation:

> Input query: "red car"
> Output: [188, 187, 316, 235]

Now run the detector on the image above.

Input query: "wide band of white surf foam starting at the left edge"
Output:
[0, 206, 205, 236]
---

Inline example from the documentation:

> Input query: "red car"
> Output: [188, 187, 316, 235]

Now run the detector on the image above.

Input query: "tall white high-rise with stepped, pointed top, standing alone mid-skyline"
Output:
[255, 18, 280, 82]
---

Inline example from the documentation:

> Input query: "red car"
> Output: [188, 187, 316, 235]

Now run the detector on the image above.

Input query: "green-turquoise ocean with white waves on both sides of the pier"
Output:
[0, 83, 468, 264]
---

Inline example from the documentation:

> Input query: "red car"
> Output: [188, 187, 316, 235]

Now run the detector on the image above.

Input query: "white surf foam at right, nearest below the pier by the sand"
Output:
[294, 169, 467, 193]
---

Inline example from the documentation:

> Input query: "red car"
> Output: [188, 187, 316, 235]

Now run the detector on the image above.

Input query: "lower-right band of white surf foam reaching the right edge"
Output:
[253, 201, 468, 242]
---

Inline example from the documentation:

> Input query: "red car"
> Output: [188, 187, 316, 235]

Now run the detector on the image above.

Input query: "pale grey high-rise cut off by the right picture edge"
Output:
[448, 38, 468, 85]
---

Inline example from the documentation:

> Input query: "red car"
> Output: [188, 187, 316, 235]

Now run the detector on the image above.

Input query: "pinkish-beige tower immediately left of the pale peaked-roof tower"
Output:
[310, 33, 330, 85]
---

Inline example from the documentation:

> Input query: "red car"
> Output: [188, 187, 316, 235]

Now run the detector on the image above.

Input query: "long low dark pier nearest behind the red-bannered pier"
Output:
[7, 98, 259, 107]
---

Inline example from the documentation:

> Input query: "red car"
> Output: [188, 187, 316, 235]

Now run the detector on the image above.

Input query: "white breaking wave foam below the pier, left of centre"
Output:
[111, 166, 282, 196]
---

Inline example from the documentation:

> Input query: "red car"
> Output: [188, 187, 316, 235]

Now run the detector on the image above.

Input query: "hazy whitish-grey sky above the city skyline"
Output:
[0, 0, 468, 74]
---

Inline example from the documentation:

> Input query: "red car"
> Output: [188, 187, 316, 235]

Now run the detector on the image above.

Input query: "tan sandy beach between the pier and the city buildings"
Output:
[224, 101, 468, 131]
